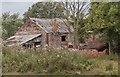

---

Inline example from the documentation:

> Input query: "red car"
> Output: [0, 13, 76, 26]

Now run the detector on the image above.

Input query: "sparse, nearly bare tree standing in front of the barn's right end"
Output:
[63, 0, 90, 48]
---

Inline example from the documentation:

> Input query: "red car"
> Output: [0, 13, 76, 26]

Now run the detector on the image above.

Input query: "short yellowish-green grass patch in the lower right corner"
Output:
[82, 53, 118, 75]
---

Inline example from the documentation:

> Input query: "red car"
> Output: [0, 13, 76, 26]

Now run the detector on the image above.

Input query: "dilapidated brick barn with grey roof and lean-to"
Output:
[6, 18, 74, 47]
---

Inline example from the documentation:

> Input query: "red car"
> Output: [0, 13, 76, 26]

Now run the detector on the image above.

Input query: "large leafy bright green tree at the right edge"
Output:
[86, 2, 120, 53]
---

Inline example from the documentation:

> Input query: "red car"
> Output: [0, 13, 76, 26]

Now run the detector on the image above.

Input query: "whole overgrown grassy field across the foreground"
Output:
[2, 47, 118, 75]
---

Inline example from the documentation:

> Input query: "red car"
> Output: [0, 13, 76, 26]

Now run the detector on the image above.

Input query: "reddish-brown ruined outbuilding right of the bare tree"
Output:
[79, 31, 106, 51]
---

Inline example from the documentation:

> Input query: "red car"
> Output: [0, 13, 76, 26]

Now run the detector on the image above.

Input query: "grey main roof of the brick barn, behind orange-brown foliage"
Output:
[30, 18, 74, 33]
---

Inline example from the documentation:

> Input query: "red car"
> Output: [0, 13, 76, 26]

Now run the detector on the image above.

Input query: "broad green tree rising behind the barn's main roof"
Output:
[23, 2, 64, 21]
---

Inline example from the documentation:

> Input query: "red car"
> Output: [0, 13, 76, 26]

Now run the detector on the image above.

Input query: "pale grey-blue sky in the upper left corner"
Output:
[2, 2, 36, 18]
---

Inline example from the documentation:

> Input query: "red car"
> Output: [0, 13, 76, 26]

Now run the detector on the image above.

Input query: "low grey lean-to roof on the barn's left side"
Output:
[6, 34, 41, 45]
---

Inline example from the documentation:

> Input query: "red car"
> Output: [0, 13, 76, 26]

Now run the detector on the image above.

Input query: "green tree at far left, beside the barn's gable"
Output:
[2, 12, 23, 40]
